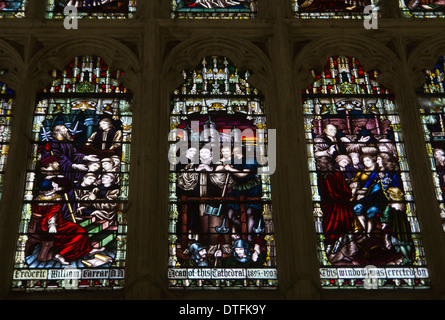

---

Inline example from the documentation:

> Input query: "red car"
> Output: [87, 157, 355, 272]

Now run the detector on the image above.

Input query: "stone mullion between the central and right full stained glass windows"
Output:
[268, 3, 318, 299]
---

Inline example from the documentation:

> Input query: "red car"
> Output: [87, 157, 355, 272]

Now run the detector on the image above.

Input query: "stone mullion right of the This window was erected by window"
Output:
[395, 72, 445, 299]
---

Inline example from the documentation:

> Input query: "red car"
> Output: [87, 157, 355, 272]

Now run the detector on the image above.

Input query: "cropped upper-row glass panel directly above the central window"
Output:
[171, 0, 259, 19]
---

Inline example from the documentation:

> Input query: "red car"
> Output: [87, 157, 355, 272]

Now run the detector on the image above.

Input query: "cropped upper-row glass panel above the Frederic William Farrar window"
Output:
[46, 0, 136, 19]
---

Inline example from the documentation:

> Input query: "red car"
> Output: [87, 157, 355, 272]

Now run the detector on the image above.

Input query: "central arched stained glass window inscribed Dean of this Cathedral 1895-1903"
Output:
[168, 56, 277, 289]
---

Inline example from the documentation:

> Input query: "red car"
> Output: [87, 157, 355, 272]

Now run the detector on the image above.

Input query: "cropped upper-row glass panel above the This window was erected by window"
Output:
[292, 0, 380, 19]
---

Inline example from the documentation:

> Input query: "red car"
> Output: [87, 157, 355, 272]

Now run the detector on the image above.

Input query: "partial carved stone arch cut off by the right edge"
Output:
[407, 34, 445, 91]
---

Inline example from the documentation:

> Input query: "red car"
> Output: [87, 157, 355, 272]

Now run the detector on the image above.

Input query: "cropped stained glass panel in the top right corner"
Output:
[399, 0, 445, 18]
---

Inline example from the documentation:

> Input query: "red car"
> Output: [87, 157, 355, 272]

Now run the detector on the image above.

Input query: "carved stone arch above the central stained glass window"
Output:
[162, 35, 272, 95]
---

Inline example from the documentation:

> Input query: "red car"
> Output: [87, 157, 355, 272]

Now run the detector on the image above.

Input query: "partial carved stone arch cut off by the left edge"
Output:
[0, 40, 26, 90]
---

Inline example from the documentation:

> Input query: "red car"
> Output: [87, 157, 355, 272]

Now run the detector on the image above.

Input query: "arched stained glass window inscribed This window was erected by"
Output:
[303, 56, 429, 289]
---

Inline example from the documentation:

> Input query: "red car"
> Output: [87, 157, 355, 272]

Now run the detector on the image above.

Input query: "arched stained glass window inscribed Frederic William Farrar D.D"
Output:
[12, 56, 132, 291]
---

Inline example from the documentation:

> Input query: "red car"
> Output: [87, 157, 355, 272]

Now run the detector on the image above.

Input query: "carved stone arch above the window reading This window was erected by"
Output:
[293, 36, 403, 94]
